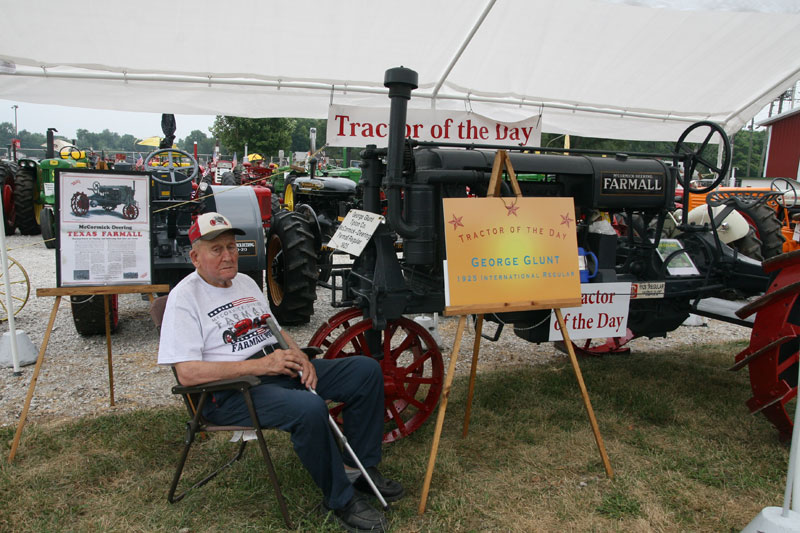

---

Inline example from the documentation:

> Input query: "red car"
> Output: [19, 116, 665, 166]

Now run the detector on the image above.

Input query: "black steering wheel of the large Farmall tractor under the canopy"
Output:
[675, 120, 731, 194]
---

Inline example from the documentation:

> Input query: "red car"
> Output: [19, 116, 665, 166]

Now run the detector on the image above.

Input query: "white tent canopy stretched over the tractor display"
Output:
[0, 0, 800, 140]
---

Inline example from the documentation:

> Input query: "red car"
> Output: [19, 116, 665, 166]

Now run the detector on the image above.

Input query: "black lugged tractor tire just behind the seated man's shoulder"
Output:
[267, 211, 318, 326]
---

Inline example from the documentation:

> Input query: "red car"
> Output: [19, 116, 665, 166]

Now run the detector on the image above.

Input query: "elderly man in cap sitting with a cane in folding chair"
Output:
[158, 213, 404, 532]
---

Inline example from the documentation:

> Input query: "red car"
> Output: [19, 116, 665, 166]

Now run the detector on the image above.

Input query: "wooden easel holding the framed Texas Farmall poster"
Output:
[8, 285, 169, 463]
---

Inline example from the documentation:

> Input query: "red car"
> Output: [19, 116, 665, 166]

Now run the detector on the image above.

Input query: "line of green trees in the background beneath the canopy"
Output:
[0, 115, 767, 178]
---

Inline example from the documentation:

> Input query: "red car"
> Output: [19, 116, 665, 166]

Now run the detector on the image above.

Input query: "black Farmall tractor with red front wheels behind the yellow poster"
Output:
[304, 68, 797, 442]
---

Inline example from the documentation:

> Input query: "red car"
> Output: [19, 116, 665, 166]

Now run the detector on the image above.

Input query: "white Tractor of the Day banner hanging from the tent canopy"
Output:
[326, 105, 542, 147]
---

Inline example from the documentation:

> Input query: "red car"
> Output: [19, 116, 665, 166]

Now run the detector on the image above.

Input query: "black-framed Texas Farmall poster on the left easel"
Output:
[55, 169, 153, 287]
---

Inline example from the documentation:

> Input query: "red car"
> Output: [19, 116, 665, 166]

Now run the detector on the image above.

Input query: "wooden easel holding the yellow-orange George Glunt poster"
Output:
[418, 150, 614, 514]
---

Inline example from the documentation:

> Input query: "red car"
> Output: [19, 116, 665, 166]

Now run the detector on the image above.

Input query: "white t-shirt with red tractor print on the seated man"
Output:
[158, 272, 277, 365]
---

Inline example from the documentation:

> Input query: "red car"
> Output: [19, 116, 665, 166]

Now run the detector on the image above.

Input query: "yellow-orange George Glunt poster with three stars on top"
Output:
[443, 197, 581, 315]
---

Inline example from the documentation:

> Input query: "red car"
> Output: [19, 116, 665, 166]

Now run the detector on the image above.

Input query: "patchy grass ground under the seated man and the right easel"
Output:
[0, 338, 788, 533]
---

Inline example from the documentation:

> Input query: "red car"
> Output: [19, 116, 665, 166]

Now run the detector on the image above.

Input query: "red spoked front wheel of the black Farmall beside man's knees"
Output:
[325, 318, 444, 443]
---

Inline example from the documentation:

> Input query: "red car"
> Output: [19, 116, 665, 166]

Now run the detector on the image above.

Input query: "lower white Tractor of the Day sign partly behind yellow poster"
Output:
[549, 283, 631, 341]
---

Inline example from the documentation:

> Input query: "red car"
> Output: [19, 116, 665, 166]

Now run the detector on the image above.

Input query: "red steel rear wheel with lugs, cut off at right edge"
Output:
[731, 251, 800, 440]
